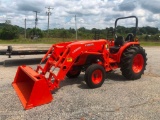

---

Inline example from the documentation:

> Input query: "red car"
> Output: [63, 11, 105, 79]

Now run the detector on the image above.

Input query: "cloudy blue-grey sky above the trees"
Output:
[0, 0, 160, 29]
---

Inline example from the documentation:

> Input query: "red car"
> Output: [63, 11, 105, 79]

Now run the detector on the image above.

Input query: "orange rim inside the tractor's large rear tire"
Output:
[132, 54, 144, 73]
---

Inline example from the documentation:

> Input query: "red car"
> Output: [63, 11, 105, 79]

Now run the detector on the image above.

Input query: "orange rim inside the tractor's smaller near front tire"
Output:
[92, 70, 103, 84]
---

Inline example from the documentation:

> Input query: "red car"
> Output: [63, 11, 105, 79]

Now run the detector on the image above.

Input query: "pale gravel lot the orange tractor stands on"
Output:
[0, 46, 160, 120]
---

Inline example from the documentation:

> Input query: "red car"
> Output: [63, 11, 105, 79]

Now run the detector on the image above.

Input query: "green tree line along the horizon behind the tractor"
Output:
[0, 23, 160, 41]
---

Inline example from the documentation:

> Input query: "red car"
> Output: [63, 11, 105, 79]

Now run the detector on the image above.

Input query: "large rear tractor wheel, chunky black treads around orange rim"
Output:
[121, 46, 147, 80]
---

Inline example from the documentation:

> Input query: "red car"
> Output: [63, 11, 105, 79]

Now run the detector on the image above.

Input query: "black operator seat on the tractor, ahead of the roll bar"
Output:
[109, 36, 124, 53]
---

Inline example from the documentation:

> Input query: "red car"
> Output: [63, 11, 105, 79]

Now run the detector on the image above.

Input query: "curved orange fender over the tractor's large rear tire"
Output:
[117, 42, 140, 63]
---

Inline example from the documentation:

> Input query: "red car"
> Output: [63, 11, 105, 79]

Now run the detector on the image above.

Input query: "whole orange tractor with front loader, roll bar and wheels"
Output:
[12, 16, 147, 109]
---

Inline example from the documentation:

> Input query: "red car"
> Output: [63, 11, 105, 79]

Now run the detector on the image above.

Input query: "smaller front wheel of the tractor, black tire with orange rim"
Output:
[84, 64, 105, 88]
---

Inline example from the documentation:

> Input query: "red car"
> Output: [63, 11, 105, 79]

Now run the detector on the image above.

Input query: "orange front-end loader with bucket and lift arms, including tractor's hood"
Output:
[12, 40, 110, 109]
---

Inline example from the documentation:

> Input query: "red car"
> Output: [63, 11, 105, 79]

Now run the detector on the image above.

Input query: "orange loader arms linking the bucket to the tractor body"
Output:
[36, 41, 106, 90]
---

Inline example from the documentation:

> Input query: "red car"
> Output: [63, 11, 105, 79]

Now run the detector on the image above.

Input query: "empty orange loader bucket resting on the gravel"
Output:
[12, 66, 53, 110]
